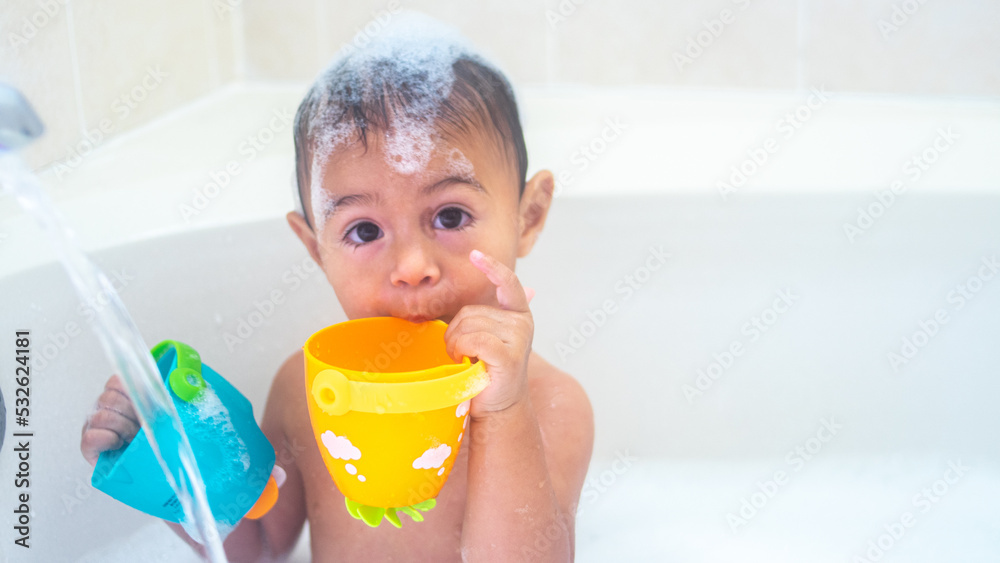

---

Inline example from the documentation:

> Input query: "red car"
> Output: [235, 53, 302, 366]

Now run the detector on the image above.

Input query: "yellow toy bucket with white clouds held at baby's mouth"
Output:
[303, 317, 489, 527]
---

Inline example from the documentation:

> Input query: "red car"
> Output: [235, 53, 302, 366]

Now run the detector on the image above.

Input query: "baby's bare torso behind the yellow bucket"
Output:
[279, 352, 469, 563]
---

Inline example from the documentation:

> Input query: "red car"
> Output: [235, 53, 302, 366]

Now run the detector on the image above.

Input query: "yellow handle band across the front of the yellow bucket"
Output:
[303, 321, 490, 416]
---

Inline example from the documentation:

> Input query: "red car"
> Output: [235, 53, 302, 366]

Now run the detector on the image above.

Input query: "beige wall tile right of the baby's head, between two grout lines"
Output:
[546, 0, 797, 89]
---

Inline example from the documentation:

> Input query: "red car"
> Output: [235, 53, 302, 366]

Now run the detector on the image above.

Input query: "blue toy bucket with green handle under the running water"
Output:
[91, 340, 278, 526]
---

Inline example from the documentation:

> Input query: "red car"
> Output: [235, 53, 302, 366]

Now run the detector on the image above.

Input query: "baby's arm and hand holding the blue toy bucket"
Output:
[80, 357, 306, 563]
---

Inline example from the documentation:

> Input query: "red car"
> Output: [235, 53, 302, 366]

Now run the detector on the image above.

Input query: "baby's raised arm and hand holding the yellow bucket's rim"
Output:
[445, 252, 594, 561]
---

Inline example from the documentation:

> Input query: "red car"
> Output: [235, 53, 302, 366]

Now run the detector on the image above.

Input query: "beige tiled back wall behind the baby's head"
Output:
[236, 0, 1000, 96]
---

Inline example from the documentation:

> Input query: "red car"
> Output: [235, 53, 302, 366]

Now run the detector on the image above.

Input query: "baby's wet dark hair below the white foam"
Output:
[294, 55, 528, 228]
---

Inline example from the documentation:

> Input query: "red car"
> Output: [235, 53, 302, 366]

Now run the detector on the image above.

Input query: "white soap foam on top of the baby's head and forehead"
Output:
[305, 11, 489, 236]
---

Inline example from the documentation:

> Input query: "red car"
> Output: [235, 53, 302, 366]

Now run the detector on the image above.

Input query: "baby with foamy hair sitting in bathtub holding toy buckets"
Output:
[81, 15, 593, 561]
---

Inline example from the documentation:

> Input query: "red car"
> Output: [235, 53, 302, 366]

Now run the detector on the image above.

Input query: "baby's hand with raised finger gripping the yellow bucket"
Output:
[444, 250, 535, 418]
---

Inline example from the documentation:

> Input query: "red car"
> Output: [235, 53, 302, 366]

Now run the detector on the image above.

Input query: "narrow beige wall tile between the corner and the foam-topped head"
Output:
[242, 0, 318, 81]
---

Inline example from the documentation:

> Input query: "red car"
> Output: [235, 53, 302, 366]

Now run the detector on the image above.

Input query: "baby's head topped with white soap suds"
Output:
[288, 13, 553, 322]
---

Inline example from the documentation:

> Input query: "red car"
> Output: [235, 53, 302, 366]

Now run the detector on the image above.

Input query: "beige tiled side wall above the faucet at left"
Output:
[0, 0, 241, 167]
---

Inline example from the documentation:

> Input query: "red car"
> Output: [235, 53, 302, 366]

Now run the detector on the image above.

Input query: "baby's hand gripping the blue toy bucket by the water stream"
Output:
[80, 375, 140, 465]
